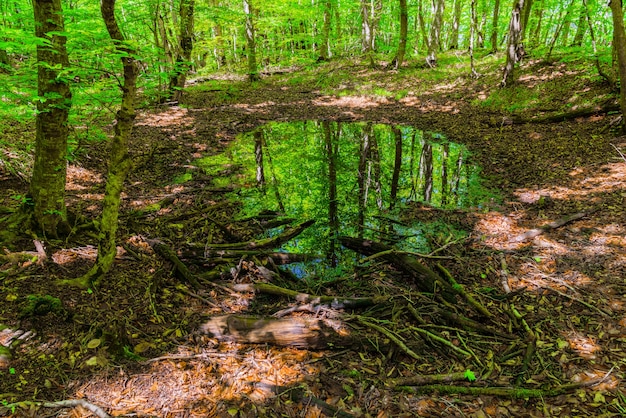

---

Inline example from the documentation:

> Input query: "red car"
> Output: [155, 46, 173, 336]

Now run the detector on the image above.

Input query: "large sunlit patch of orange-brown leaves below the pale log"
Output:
[75, 344, 323, 417]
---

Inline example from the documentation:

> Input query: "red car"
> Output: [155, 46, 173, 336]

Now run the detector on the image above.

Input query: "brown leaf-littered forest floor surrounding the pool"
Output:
[0, 56, 626, 417]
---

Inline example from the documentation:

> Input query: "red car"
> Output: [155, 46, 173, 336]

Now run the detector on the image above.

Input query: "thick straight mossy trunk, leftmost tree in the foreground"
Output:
[30, 0, 72, 237]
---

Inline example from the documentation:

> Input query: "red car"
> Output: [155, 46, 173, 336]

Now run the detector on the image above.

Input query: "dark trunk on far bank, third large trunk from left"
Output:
[170, 0, 195, 102]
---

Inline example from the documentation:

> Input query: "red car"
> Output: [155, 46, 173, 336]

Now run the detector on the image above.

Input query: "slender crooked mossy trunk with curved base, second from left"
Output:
[69, 0, 139, 287]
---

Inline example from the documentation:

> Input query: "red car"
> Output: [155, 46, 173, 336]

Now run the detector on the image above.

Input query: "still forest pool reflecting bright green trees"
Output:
[190, 121, 493, 275]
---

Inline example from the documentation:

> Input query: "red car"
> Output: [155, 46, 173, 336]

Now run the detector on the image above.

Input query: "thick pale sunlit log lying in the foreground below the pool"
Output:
[200, 315, 352, 350]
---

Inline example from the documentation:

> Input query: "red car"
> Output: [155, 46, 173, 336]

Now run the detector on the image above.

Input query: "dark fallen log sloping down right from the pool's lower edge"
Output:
[339, 236, 455, 303]
